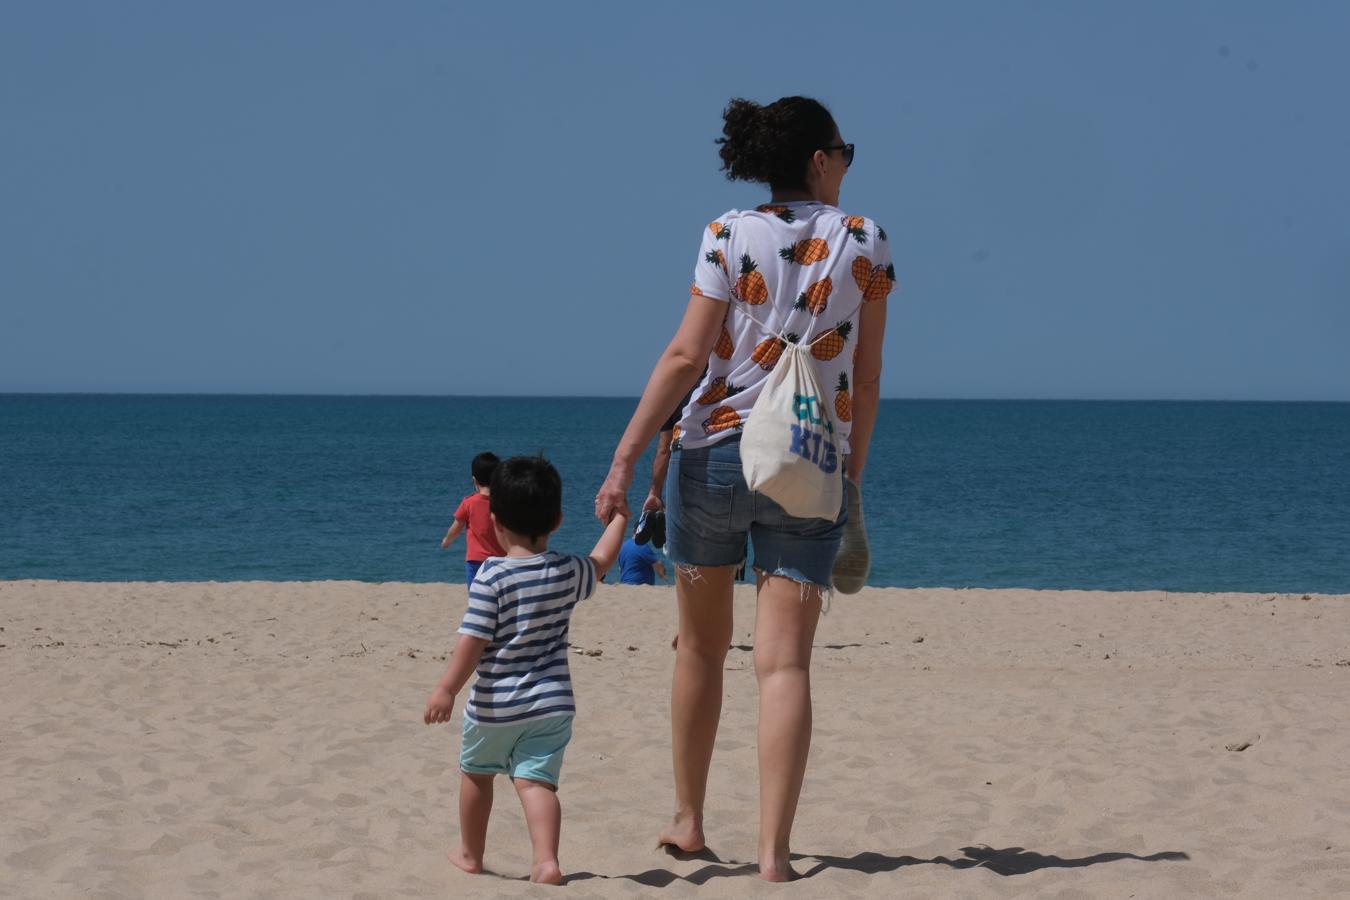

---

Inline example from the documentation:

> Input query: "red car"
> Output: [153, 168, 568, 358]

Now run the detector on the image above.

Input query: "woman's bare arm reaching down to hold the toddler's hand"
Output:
[595, 294, 728, 524]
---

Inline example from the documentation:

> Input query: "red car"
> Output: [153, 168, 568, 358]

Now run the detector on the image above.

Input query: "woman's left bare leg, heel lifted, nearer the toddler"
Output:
[660, 565, 736, 853]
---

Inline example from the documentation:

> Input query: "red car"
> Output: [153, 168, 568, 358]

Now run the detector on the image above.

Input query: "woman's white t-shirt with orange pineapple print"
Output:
[674, 200, 895, 453]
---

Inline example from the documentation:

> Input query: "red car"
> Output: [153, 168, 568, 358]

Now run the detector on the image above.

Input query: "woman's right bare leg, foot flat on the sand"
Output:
[755, 575, 821, 881]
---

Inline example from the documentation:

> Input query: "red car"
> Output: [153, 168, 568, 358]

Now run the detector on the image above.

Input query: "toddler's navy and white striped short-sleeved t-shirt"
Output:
[459, 551, 595, 725]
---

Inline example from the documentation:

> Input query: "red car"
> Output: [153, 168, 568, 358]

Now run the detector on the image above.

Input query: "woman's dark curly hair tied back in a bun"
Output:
[717, 97, 838, 189]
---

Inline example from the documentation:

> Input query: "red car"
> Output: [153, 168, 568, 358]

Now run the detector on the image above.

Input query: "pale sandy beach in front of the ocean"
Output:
[0, 582, 1350, 899]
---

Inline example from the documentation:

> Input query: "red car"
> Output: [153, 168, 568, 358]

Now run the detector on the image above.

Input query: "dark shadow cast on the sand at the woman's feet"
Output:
[563, 847, 1191, 888]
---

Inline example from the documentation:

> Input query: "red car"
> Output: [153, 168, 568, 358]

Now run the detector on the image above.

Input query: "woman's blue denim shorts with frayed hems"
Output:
[666, 434, 848, 590]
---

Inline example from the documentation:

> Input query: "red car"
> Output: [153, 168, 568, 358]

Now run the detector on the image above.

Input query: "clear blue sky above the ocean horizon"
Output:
[0, 1, 1350, 399]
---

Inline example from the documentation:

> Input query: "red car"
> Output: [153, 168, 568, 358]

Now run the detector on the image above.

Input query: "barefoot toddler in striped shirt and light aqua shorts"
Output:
[423, 456, 628, 884]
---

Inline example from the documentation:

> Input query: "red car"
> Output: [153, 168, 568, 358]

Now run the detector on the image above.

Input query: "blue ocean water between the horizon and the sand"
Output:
[0, 395, 1350, 592]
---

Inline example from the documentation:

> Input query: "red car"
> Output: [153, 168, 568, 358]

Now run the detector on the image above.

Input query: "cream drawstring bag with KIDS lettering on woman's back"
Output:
[741, 323, 844, 522]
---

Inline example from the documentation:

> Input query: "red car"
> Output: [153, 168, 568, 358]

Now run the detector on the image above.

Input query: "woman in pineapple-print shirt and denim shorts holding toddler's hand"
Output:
[595, 97, 895, 881]
